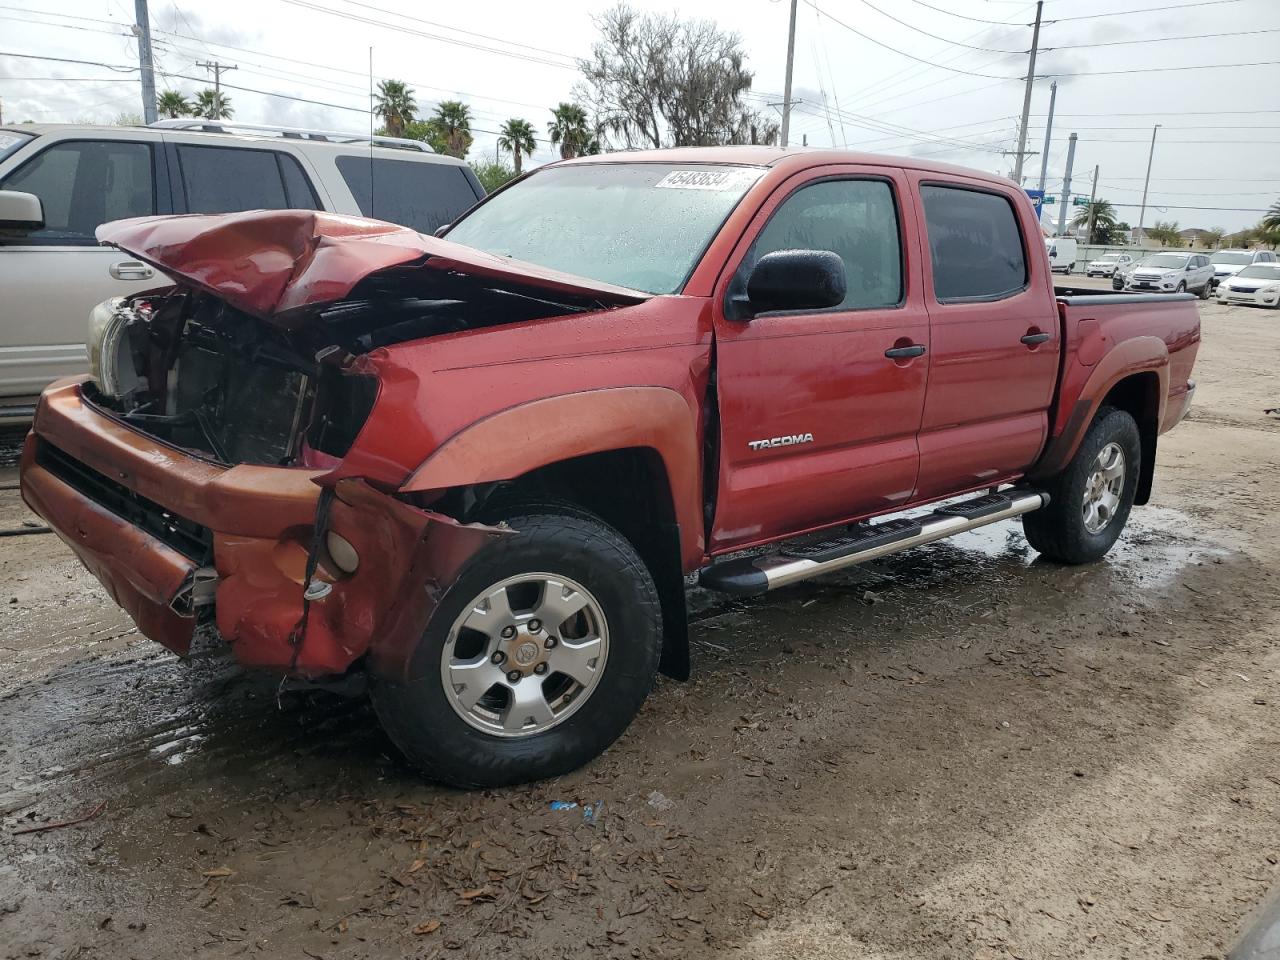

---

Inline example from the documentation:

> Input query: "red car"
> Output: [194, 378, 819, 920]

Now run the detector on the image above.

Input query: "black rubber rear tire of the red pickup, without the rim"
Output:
[1023, 407, 1142, 563]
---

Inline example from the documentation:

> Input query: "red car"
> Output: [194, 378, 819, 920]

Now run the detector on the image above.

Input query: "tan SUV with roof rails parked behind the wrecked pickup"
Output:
[0, 120, 484, 424]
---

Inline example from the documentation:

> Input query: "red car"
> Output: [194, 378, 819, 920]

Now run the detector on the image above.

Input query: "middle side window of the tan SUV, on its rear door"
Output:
[178, 143, 320, 214]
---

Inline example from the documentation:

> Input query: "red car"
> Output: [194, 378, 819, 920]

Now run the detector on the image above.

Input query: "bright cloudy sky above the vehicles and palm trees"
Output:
[0, 0, 1280, 230]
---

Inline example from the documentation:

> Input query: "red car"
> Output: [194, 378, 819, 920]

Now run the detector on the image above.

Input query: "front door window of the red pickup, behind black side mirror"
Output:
[730, 180, 902, 310]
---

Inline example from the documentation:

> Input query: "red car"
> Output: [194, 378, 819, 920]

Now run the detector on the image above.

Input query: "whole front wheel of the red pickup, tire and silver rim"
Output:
[372, 508, 662, 787]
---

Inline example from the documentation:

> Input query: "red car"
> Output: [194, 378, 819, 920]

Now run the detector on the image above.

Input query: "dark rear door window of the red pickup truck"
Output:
[920, 186, 1027, 302]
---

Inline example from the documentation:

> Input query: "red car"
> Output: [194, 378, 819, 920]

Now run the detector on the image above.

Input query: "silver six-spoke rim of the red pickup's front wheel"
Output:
[440, 573, 609, 737]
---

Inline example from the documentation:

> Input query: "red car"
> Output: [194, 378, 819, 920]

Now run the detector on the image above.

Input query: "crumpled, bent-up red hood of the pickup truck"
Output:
[97, 210, 650, 326]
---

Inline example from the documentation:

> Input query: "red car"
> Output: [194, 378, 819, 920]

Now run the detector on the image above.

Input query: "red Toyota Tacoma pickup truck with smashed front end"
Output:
[22, 147, 1199, 785]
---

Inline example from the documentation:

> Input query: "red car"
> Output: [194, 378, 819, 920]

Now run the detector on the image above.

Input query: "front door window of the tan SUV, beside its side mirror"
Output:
[0, 140, 156, 246]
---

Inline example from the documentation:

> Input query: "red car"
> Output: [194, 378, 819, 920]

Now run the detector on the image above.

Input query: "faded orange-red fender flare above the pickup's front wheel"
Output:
[401, 387, 705, 570]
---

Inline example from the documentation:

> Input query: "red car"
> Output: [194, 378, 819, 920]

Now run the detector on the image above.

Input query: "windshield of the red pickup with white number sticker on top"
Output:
[448, 163, 764, 293]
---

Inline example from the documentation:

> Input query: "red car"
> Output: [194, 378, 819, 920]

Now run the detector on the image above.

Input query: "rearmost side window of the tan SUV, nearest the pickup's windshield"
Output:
[337, 156, 476, 233]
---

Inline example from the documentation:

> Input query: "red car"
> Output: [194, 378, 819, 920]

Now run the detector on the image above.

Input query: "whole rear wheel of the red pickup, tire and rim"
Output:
[1023, 407, 1142, 563]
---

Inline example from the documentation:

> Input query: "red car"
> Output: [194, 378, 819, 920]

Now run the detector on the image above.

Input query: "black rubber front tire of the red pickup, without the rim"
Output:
[371, 507, 662, 787]
